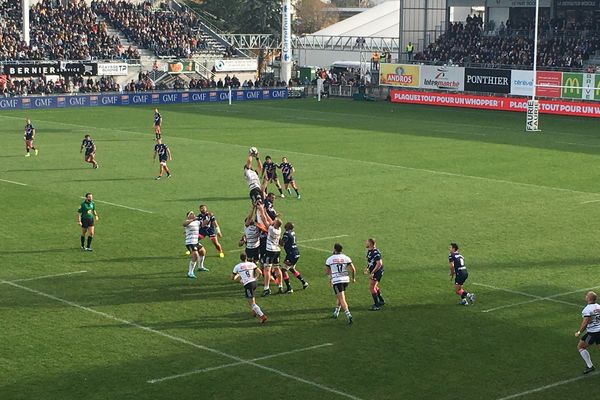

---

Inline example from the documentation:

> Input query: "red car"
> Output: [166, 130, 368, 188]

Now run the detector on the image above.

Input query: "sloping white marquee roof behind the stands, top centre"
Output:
[313, 0, 400, 37]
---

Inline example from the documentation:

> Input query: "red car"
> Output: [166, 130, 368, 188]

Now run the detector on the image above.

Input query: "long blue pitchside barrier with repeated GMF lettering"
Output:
[0, 88, 288, 110]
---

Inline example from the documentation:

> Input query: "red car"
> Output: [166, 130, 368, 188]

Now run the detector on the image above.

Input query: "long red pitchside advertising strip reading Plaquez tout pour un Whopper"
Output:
[390, 90, 600, 118]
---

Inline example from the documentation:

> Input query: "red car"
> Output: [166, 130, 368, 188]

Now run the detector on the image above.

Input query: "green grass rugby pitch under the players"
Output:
[0, 100, 600, 400]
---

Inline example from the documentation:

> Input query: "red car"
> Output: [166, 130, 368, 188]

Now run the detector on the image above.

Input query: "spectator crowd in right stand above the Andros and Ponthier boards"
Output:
[414, 16, 600, 68]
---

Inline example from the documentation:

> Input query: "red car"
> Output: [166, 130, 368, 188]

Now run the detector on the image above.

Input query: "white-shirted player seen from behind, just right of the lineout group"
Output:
[325, 243, 356, 324]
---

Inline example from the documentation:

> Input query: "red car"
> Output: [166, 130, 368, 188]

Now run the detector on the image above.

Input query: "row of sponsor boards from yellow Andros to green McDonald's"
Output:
[379, 63, 600, 101]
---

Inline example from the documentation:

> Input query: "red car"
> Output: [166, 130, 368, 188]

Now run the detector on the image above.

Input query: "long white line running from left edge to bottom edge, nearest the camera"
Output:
[0, 280, 362, 400]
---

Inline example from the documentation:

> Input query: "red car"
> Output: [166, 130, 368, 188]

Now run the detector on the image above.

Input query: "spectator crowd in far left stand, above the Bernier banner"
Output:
[0, 0, 139, 61]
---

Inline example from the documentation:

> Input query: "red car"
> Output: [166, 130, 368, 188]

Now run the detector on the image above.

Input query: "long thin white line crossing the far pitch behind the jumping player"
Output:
[0, 111, 600, 196]
